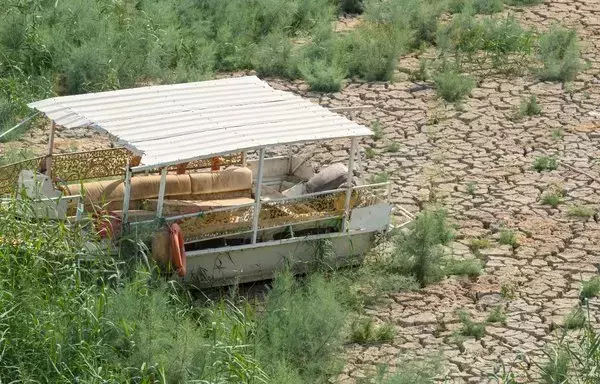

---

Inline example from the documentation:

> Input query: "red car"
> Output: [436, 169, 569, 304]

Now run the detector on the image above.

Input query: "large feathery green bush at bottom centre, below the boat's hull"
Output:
[257, 272, 347, 382]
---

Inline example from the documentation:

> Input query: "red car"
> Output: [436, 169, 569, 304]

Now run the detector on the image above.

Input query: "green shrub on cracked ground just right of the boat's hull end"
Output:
[389, 209, 454, 286]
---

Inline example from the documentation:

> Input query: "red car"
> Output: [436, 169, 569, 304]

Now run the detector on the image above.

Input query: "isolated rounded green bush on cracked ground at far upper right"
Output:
[539, 26, 582, 82]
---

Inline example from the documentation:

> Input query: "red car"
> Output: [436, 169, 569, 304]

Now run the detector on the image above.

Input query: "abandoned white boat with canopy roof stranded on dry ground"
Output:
[0, 76, 412, 287]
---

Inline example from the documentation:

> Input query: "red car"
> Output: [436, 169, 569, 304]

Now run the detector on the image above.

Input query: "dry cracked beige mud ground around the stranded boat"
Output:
[0, 0, 600, 383]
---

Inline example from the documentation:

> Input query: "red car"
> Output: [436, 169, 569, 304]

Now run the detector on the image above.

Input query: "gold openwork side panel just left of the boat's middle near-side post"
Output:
[179, 207, 254, 240]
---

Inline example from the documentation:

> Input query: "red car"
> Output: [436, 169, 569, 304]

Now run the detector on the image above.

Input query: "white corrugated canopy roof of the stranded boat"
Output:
[29, 76, 371, 167]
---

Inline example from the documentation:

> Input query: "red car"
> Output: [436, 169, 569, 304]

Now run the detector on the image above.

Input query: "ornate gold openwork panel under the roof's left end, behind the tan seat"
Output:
[52, 148, 135, 181]
